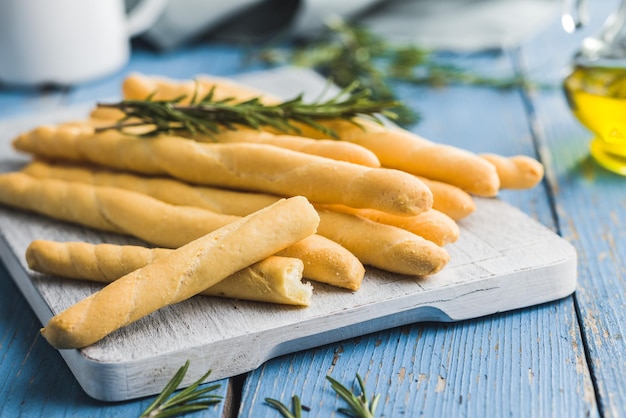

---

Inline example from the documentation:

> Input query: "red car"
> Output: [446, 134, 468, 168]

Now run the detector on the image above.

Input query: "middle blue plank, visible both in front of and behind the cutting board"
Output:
[240, 51, 599, 417]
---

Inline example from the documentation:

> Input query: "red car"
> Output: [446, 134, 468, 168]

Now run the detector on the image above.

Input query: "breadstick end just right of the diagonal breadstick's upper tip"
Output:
[318, 208, 450, 276]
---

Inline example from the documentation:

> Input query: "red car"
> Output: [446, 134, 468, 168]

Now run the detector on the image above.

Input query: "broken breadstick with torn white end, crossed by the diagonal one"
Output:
[26, 240, 313, 306]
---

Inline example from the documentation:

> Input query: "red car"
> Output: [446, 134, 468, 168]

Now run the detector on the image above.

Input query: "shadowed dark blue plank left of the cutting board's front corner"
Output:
[0, 263, 228, 418]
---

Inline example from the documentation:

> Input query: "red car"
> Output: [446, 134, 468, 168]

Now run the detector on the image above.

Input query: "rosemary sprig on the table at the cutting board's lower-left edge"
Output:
[139, 360, 222, 418]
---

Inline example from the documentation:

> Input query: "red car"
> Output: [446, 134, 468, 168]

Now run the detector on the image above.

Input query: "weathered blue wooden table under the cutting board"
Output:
[0, 1, 626, 418]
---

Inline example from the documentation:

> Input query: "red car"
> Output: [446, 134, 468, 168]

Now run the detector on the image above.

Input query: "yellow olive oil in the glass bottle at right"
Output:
[563, 66, 626, 176]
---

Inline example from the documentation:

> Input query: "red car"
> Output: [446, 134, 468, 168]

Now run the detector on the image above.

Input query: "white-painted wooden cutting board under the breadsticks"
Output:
[0, 70, 576, 401]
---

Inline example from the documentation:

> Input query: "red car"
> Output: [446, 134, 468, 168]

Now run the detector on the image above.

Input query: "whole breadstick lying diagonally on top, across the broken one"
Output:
[41, 197, 319, 349]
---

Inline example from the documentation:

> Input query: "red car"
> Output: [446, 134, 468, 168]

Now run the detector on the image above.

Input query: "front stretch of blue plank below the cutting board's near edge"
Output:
[240, 298, 597, 418]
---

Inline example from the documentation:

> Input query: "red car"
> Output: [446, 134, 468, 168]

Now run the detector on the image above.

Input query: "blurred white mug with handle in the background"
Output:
[0, 0, 166, 85]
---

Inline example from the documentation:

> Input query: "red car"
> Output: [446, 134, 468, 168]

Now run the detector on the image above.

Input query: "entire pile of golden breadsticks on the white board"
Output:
[0, 75, 543, 348]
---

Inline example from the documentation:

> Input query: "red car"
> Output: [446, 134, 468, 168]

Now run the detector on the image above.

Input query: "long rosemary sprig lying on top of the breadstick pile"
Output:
[97, 83, 397, 138]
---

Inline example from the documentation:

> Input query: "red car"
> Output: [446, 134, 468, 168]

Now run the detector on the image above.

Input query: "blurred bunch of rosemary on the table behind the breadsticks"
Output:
[253, 18, 539, 127]
